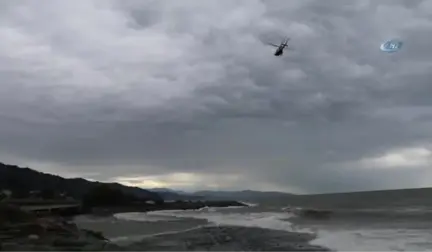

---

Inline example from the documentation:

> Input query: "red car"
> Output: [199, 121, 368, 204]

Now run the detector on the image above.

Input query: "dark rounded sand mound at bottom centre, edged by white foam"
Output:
[127, 226, 329, 252]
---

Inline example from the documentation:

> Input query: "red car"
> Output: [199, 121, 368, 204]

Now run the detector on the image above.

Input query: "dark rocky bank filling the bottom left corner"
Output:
[0, 204, 122, 252]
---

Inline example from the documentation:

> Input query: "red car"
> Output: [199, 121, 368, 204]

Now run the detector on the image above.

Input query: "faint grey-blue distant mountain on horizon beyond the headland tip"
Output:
[194, 190, 293, 201]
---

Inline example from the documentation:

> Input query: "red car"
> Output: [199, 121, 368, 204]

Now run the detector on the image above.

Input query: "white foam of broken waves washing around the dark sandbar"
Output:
[111, 208, 432, 252]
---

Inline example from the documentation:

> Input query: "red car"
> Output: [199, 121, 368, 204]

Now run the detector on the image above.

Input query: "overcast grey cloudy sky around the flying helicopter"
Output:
[0, 0, 432, 193]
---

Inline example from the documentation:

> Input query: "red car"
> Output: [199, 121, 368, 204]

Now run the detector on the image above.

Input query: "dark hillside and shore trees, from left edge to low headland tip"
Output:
[0, 163, 245, 214]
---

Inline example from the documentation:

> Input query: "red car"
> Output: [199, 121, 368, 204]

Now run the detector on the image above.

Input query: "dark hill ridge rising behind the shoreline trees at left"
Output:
[0, 163, 162, 201]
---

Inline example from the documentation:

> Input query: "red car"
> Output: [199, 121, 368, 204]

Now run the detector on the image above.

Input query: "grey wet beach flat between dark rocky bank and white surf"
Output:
[76, 217, 329, 252]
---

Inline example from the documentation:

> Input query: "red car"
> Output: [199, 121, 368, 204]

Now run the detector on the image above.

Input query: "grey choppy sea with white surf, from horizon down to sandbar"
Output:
[76, 189, 432, 252]
